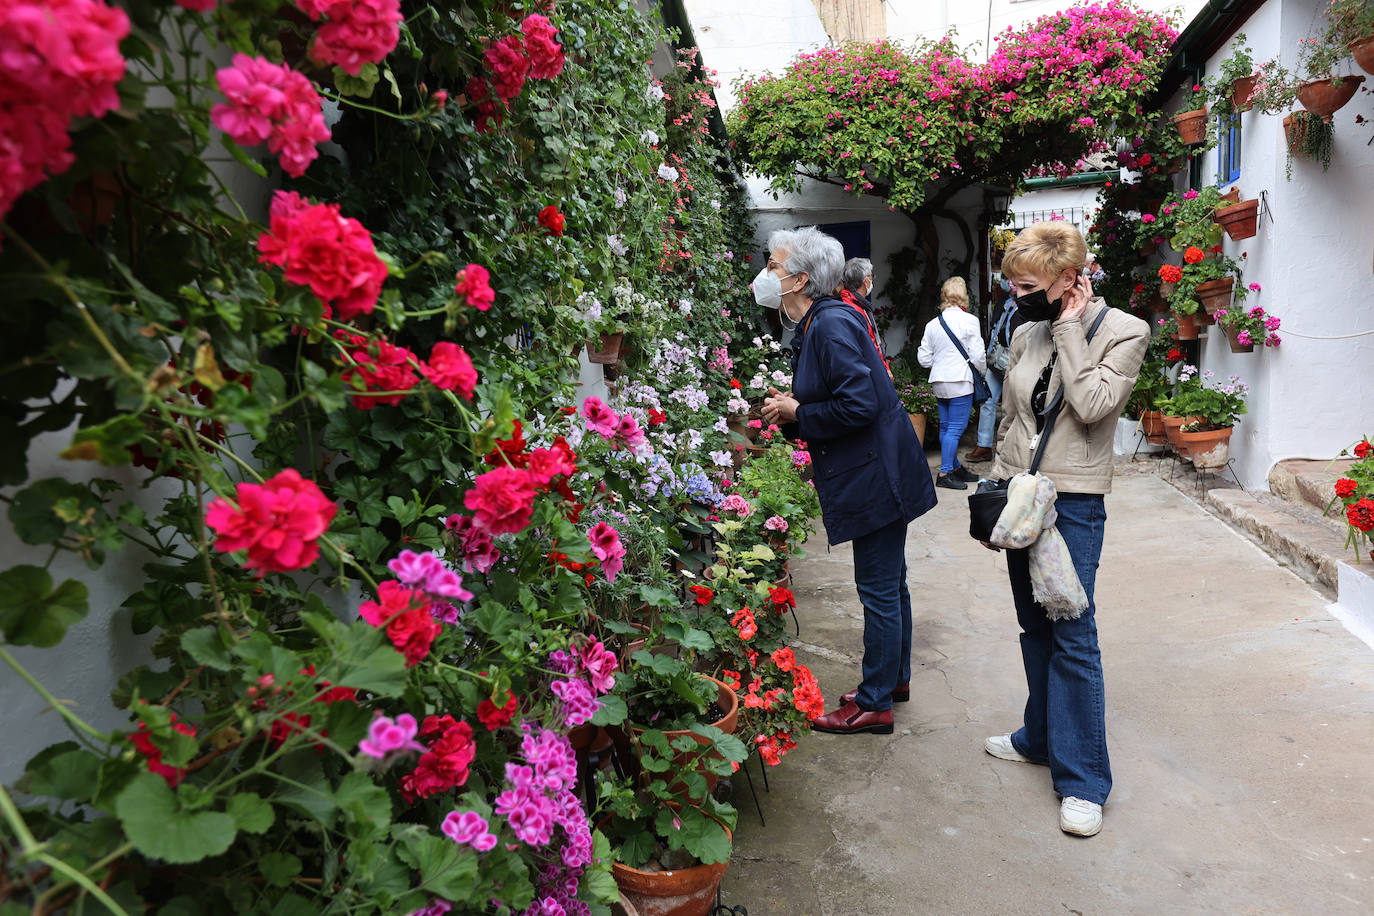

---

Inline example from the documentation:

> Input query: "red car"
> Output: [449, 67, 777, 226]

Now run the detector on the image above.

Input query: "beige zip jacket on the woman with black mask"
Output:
[992, 298, 1150, 493]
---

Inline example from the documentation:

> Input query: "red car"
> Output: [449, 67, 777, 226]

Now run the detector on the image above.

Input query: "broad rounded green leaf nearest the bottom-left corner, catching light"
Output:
[114, 773, 236, 864]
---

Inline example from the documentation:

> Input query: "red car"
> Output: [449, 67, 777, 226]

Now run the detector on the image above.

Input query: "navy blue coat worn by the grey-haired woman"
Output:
[791, 297, 936, 544]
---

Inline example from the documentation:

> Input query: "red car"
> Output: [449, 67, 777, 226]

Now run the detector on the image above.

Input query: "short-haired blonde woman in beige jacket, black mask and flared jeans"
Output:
[984, 221, 1150, 836]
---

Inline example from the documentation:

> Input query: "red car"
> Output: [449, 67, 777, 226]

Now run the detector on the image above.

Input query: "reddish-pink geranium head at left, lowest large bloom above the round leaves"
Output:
[205, 468, 338, 575]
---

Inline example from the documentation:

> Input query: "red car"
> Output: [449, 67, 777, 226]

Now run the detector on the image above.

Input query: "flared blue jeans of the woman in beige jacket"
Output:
[1007, 493, 1112, 805]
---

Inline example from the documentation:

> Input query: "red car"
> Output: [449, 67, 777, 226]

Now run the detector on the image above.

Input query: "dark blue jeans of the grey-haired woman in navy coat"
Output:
[853, 522, 911, 710]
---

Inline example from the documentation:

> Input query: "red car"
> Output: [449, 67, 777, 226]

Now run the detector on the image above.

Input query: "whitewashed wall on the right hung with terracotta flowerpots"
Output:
[1176, 0, 1374, 488]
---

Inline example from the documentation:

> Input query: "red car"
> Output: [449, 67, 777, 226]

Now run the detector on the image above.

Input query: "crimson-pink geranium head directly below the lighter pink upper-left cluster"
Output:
[256, 192, 386, 321]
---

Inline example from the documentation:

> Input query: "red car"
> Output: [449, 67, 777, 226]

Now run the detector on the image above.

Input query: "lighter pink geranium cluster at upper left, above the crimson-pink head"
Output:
[210, 54, 330, 177]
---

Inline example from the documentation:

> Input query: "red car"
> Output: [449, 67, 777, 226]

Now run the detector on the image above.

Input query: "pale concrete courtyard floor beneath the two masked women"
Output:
[723, 475, 1374, 916]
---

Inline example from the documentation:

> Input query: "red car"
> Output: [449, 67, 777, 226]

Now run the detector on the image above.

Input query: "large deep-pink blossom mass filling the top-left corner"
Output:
[0, 0, 129, 218]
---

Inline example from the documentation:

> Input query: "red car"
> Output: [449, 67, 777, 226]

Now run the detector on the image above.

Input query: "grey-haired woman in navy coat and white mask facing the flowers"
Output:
[754, 227, 936, 735]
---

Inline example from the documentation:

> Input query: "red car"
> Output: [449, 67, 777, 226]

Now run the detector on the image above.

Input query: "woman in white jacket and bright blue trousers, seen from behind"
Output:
[916, 276, 988, 490]
